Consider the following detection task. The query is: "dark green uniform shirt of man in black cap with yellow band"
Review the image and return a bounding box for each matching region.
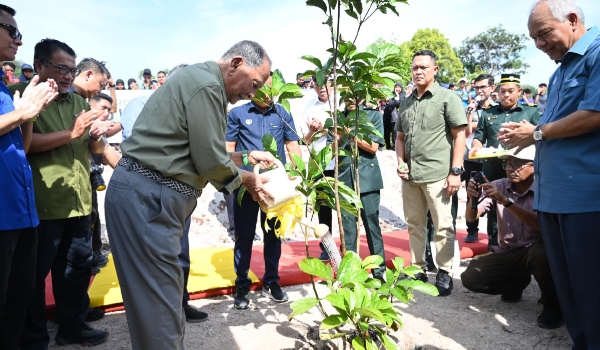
[475,103,540,181]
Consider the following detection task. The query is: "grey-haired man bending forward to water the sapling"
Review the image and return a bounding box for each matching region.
[105,41,274,350]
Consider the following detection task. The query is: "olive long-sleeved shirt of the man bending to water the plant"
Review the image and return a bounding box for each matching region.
[121,62,242,193]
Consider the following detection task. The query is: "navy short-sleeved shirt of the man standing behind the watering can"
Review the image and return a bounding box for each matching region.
[225,102,299,171]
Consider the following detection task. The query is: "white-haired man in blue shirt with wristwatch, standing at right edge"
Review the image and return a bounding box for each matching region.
[499,0,600,349]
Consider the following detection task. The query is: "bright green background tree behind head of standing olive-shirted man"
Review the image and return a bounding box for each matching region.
[400,28,464,83]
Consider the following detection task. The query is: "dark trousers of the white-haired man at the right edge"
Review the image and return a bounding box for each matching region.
[538,211,600,349]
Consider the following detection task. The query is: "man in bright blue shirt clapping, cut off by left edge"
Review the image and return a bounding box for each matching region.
[0,5,58,349]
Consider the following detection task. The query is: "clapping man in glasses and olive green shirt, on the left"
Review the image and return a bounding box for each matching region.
[15,39,108,349]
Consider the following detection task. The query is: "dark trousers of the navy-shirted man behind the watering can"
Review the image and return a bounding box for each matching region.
[233,190,281,288]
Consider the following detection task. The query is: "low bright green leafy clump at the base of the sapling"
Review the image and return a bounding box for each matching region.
[289,252,438,349]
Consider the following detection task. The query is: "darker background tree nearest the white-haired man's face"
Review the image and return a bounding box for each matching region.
[456,24,529,75]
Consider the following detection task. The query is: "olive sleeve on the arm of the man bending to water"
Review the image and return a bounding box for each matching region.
[185,86,242,194]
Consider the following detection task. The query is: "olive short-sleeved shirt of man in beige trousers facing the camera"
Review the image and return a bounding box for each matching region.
[395,83,467,183]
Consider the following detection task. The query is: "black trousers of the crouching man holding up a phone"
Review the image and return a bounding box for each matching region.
[460,241,558,308]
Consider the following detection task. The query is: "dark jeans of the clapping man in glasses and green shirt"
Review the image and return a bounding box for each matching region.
[21,215,92,350]
